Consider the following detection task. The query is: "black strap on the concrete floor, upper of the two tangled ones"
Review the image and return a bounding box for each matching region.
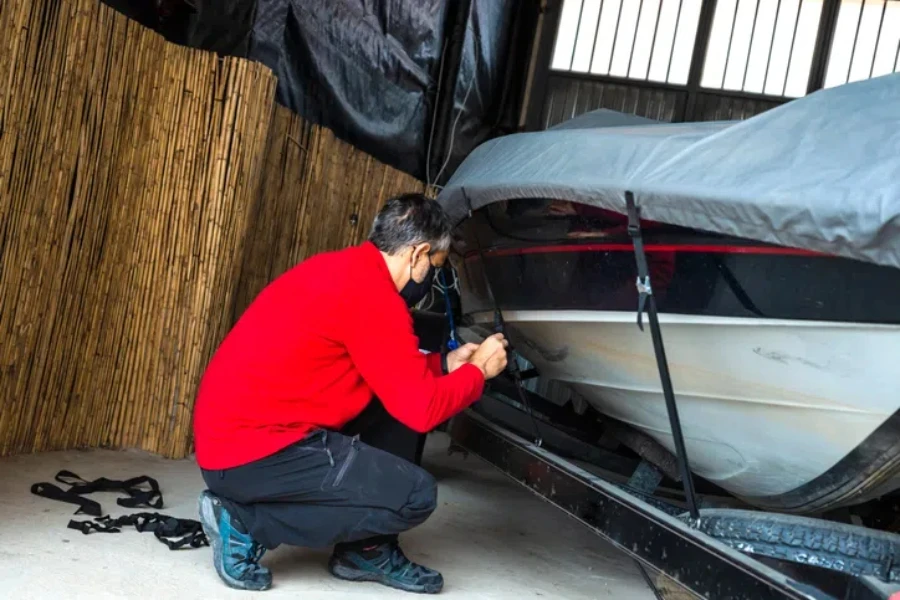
[31,471,163,517]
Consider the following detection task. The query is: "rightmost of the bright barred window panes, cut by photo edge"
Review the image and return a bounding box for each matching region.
[825,0,900,87]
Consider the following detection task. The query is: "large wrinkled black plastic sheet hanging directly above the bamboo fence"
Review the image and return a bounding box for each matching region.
[262,0,445,176]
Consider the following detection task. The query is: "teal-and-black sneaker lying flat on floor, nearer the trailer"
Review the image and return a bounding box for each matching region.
[328,542,444,594]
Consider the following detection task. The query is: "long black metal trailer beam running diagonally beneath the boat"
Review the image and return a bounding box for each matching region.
[448,409,900,600]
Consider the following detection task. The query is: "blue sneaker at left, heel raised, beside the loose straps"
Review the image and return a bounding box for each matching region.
[199,490,272,591]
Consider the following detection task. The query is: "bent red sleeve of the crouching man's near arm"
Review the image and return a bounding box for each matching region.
[344,294,484,433]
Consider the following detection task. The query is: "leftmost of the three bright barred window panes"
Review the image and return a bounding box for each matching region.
[551,0,702,85]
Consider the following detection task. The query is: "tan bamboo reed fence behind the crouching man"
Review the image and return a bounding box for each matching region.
[0,0,422,458]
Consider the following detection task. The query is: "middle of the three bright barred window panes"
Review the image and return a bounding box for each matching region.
[700,0,822,97]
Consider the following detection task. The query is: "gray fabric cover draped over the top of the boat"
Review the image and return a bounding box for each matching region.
[438,74,900,268]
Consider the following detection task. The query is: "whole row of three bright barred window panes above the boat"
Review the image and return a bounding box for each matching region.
[551,0,900,98]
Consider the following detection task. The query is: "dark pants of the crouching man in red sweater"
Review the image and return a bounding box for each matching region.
[203,400,437,549]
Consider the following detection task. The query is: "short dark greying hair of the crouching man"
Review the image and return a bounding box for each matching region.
[369,193,453,254]
